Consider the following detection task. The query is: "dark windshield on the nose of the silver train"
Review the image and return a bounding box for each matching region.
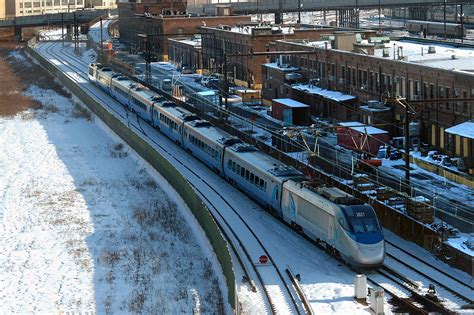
[344,205,380,233]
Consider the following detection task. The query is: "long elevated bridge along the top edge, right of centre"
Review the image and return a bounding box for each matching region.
[188,0,474,14]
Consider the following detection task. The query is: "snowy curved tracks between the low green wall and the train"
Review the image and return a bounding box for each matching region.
[39,43,312,314]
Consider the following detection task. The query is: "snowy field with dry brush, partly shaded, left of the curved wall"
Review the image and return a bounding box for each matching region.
[0,54,228,314]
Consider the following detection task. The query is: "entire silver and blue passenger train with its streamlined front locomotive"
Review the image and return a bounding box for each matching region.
[88,64,385,268]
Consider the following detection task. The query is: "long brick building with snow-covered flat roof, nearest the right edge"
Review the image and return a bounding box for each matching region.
[262,40,474,170]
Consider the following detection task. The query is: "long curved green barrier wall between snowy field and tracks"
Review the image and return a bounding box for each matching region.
[26,39,239,313]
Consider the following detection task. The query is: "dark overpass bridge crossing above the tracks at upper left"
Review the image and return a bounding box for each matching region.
[0,9,116,29]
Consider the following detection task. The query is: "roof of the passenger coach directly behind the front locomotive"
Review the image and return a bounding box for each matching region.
[229,143,303,178]
